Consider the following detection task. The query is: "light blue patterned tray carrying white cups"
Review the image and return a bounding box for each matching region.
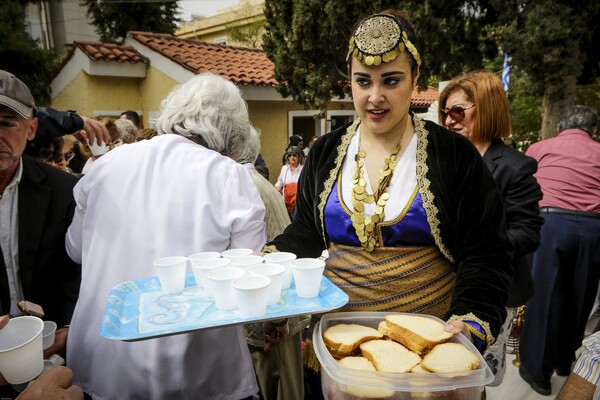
[100,273,348,341]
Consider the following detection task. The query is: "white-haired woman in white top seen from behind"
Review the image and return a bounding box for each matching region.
[67,74,288,400]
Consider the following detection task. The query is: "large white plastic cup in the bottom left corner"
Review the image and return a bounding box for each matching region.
[0,316,44,385]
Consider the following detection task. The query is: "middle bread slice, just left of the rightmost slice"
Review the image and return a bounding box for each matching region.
[360,340,421,372]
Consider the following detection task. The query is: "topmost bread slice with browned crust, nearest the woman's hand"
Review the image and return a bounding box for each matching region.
[385,314,453,354]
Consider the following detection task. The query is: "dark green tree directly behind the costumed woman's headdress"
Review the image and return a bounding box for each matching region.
[263,0,496,109]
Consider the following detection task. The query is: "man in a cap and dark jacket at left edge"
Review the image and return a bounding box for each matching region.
[0,70,81,397]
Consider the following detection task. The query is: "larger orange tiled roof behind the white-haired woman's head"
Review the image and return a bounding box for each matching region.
[130,32,277,86]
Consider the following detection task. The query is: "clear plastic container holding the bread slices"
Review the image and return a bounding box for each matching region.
[313,312,494,400]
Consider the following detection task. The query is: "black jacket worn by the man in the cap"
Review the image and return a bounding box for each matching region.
[0,155,81,327]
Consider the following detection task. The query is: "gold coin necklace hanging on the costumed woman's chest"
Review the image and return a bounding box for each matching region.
[350,130,408,252]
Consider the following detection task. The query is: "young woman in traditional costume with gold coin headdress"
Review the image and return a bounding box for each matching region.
[264,10,512,362]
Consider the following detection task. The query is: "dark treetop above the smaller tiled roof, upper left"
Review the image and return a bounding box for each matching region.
[83,0,181,43]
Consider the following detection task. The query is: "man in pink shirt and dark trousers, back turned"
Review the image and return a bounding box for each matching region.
[519,106,600,396]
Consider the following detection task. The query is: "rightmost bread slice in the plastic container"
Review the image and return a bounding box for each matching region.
[421,342,479,372]
